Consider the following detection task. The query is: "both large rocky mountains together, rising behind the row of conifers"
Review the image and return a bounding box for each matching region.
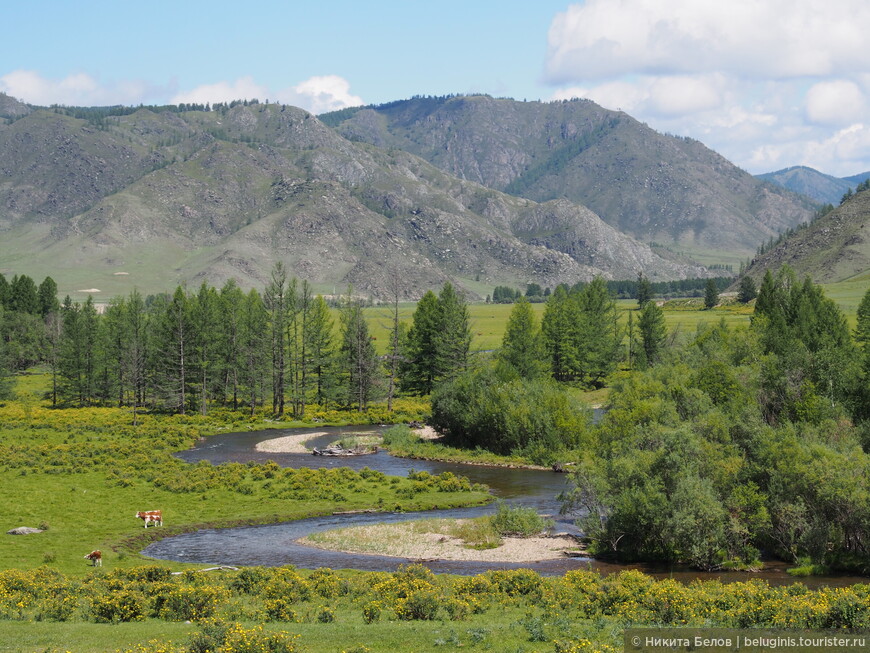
[0,94,809,298]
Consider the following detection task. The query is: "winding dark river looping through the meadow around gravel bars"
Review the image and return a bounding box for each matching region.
[143,426,867,587]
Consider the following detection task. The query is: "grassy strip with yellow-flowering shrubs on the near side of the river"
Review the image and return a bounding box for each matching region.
[0,565,870,653]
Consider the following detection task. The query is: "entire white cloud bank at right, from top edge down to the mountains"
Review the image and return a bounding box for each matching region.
[545,0,870,175]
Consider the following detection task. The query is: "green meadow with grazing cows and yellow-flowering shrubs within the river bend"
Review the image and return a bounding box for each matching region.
[0,376,491,574]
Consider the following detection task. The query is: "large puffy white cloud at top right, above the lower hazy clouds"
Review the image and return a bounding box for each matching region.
[547,0,870,84]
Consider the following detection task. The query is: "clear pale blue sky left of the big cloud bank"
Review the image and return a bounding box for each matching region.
[0,0,567,103]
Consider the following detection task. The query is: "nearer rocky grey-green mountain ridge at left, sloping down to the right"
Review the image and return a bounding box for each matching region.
[0,96,705,297]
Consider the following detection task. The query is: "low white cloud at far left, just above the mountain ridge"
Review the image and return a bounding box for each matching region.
[0,70,154,106]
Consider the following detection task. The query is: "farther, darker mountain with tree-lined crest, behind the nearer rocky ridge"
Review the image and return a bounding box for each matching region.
[321,96,813,253]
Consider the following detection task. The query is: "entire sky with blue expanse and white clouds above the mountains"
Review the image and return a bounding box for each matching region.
[0,0,870,176]
